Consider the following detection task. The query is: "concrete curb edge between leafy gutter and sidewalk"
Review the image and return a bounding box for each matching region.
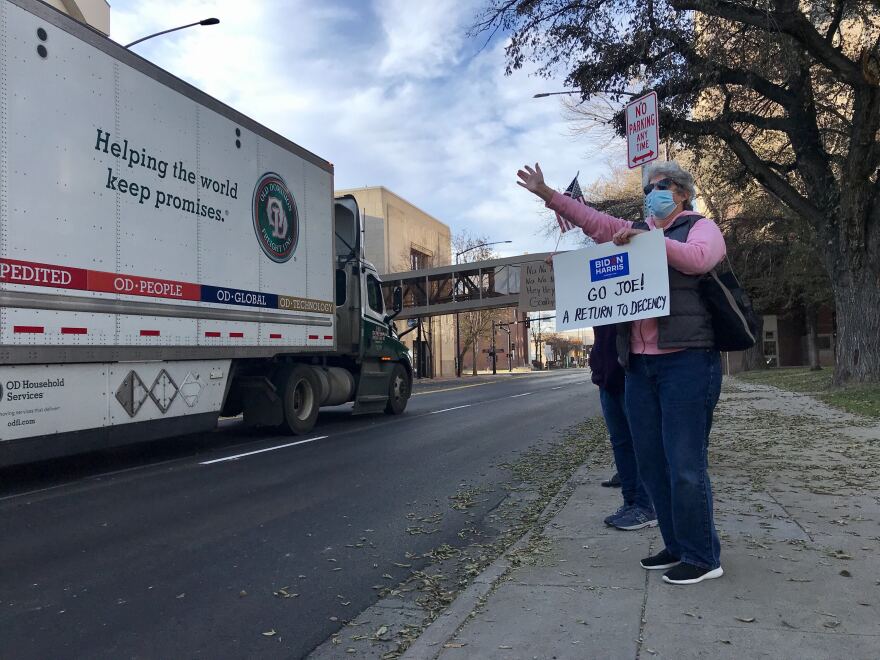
[400,466,585,660]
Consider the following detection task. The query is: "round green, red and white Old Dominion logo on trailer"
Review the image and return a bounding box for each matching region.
[252,172,299,263]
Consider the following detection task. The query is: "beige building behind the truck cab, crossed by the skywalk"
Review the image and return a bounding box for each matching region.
[336,186,455,378]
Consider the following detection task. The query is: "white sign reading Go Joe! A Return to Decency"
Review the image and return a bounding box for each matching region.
[553,229,669,330]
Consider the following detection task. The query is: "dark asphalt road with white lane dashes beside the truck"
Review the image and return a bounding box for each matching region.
[0,370,599,658]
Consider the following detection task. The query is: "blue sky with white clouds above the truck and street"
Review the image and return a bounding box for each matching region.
[110,0,626,256]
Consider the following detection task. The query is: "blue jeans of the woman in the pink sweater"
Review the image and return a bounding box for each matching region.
[626,349,721,569]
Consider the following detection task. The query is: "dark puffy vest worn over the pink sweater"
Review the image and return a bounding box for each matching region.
[617,213,715,367]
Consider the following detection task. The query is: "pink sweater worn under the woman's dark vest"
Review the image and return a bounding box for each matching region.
[547,193,727,355]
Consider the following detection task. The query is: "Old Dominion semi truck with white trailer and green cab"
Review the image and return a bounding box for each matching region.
[0,0,413,466]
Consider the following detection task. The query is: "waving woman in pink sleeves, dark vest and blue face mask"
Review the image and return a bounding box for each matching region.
[517,161,726,584]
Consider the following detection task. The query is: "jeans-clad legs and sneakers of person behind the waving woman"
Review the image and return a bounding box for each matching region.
[589,325,657,530]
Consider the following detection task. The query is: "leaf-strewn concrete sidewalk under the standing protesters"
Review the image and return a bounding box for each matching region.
[403,379,880,660]
